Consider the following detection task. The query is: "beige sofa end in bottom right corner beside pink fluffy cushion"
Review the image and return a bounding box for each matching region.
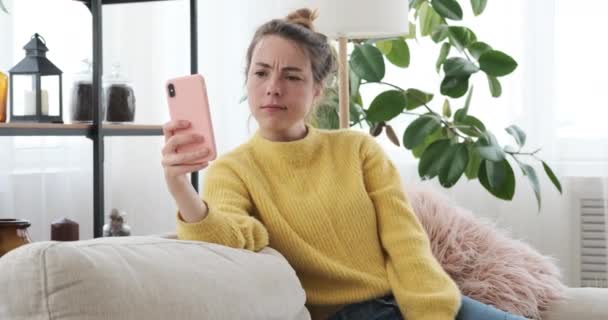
[542,288,608,320]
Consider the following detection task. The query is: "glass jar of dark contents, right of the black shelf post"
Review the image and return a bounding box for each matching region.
[104,64,135,122]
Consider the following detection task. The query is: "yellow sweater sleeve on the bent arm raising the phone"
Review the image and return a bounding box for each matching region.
[177,162,268,251]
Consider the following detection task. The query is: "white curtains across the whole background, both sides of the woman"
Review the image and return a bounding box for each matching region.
[0,0,608,285]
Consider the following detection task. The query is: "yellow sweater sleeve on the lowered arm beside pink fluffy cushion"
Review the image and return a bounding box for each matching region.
[361,137,460,320]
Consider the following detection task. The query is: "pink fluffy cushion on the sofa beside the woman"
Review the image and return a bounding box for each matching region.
[407,186,565,319]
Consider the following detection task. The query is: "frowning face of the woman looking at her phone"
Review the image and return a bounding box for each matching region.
[247,35,321,132]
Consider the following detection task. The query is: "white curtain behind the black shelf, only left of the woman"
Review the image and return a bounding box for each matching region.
[0,0,290,240]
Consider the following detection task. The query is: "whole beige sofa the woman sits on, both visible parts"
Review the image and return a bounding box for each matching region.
[0,237,608,320]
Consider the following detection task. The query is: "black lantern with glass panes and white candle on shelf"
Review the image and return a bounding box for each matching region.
[9,33,63,123]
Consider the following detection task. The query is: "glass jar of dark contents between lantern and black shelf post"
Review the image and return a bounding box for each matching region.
[70,59,105,122]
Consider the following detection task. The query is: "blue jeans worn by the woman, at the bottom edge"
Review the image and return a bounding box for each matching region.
[328,295,526,320]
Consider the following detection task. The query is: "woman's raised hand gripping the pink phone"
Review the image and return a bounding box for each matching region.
[162,120,209,184]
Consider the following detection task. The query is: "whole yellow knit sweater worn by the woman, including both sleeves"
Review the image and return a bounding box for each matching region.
[177,127,460,320]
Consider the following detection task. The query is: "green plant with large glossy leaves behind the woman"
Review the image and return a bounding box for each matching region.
[316,0,562,210]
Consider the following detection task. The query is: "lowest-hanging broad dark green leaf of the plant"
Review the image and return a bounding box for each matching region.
[478,159,515,200]
